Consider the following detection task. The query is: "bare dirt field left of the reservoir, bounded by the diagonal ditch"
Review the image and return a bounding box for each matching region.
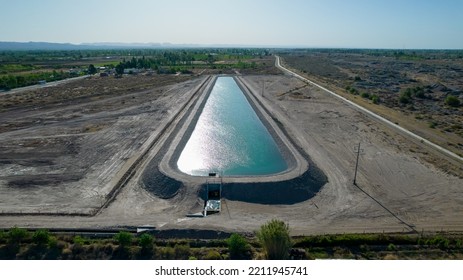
[0,74,201,214]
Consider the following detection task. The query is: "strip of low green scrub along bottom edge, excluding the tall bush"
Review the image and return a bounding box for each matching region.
[0,228,463,260]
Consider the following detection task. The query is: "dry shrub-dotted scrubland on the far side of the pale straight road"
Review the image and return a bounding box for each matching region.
[284,50,463,176]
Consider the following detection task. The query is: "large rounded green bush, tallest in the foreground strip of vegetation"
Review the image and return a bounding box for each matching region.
[257,219,291,260]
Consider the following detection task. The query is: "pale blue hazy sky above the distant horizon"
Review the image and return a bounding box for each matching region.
[0,0,463,49]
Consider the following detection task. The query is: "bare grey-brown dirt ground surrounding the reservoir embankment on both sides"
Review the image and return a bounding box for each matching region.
[0,70,463,235]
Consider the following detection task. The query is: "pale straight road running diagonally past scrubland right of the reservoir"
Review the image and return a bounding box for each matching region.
[275,56,463,162]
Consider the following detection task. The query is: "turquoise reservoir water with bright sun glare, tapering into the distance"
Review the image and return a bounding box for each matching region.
[177,77,288,176]
